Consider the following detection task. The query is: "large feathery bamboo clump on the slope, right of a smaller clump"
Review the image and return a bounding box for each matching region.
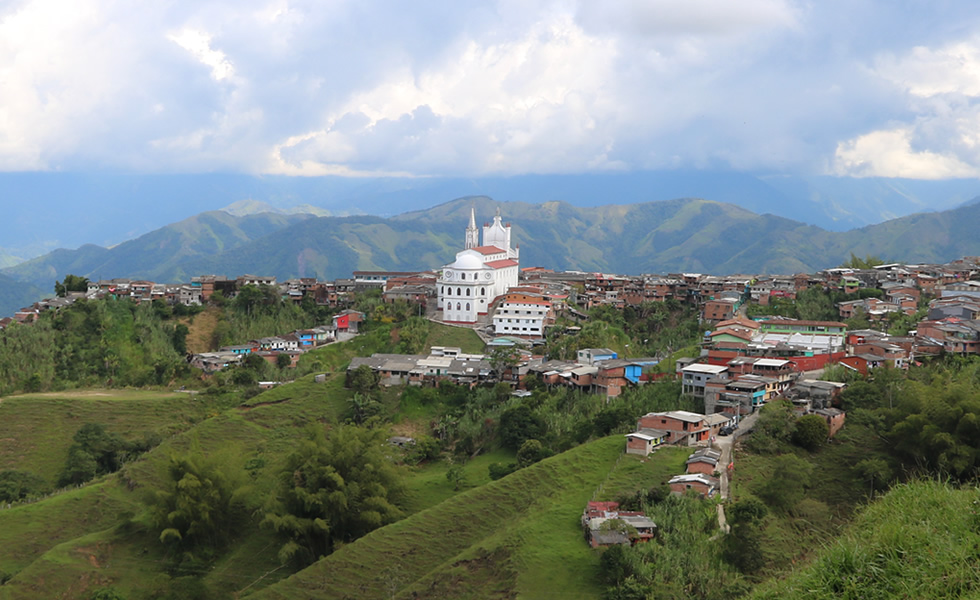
[263,425,402,565]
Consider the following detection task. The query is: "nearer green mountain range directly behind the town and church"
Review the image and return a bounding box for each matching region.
[0,196,980,314]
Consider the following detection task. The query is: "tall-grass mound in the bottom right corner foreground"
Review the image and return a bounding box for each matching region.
[751,481,980,600]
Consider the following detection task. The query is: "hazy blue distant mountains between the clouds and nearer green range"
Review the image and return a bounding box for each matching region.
[0,170,980,268]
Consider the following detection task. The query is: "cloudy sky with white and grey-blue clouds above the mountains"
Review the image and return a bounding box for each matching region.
[0,0,980,179]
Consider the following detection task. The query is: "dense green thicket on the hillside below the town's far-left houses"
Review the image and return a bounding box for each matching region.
[0,288,348,394]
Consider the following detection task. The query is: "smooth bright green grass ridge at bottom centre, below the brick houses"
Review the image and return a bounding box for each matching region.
[249,436,686,599]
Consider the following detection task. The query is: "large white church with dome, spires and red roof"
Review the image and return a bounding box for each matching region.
[436,208,520,323]
